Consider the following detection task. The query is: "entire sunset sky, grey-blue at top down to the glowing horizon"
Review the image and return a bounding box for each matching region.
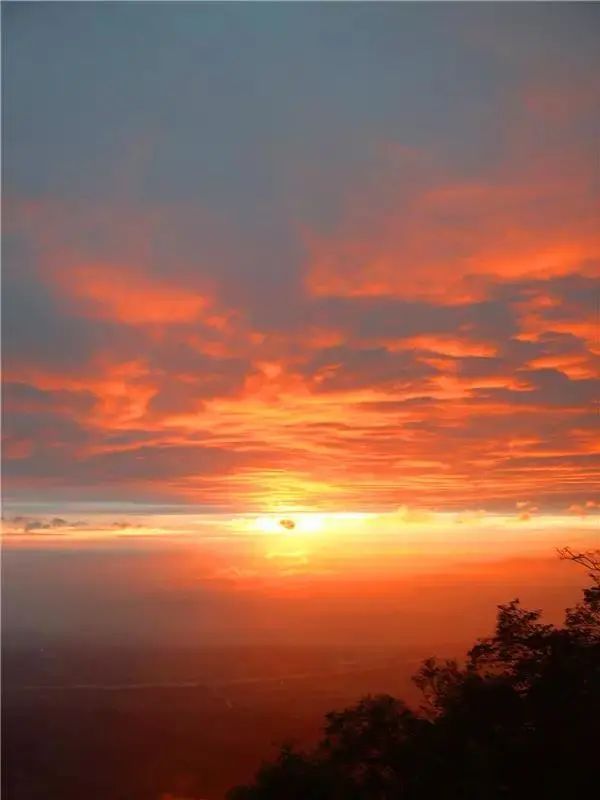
[2,3,600,600]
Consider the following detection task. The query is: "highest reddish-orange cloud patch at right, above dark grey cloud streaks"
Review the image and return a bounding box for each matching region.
[306,145,600,303]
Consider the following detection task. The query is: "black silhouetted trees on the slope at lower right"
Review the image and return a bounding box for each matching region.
[228,550,600,800]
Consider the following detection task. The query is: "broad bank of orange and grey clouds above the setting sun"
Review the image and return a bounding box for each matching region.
[5,122,600,516]
